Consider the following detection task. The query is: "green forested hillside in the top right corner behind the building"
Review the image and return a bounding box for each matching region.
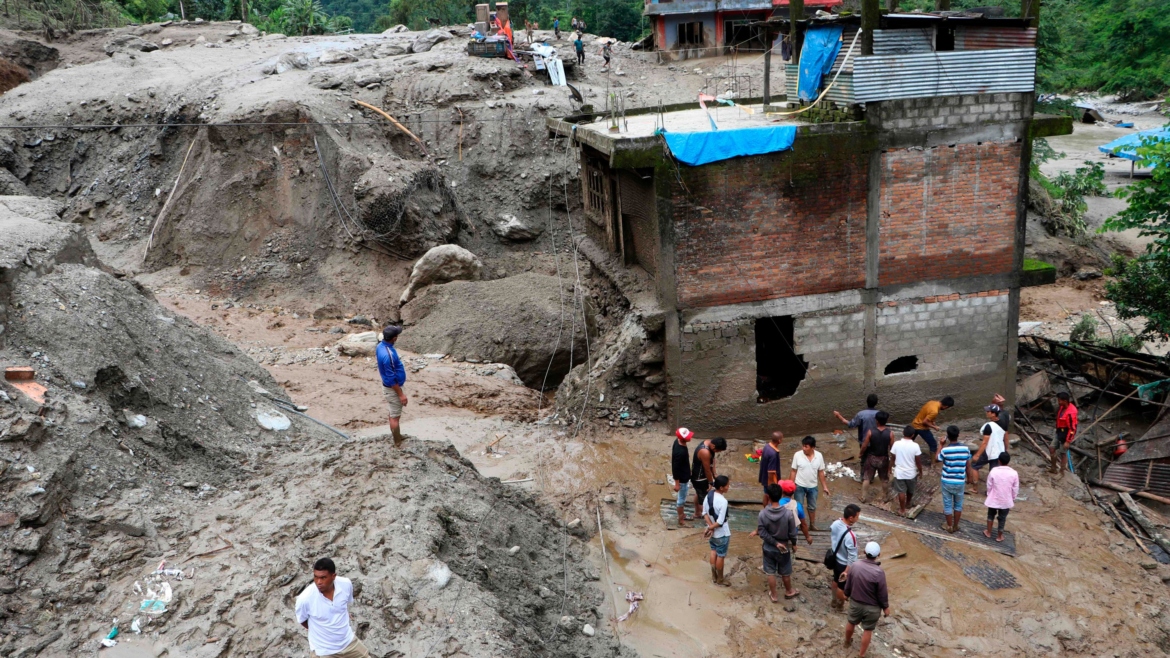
[1037,0,1170,100]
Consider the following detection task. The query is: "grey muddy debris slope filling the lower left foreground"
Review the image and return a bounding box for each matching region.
[0,197,621,658]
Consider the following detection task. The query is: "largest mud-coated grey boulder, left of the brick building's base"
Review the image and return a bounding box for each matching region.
[398,273,597,389]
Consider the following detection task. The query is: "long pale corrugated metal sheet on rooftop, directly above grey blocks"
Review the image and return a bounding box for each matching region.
[853,48,1035,103]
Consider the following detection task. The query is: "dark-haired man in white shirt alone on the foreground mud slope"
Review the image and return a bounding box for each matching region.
[296,557,370,658]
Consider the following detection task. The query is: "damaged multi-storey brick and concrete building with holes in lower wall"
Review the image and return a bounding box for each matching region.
[549,6,1072,436]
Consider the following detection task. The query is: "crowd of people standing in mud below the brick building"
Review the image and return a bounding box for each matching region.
[670,393,1043,656]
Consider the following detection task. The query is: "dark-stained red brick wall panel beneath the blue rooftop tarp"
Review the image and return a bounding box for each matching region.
[672,148,868,308]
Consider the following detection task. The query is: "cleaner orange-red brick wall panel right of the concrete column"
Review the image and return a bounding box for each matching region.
[878,142,1021,286]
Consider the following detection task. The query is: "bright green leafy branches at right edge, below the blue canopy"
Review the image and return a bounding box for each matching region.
[1102,134,1170,341]
